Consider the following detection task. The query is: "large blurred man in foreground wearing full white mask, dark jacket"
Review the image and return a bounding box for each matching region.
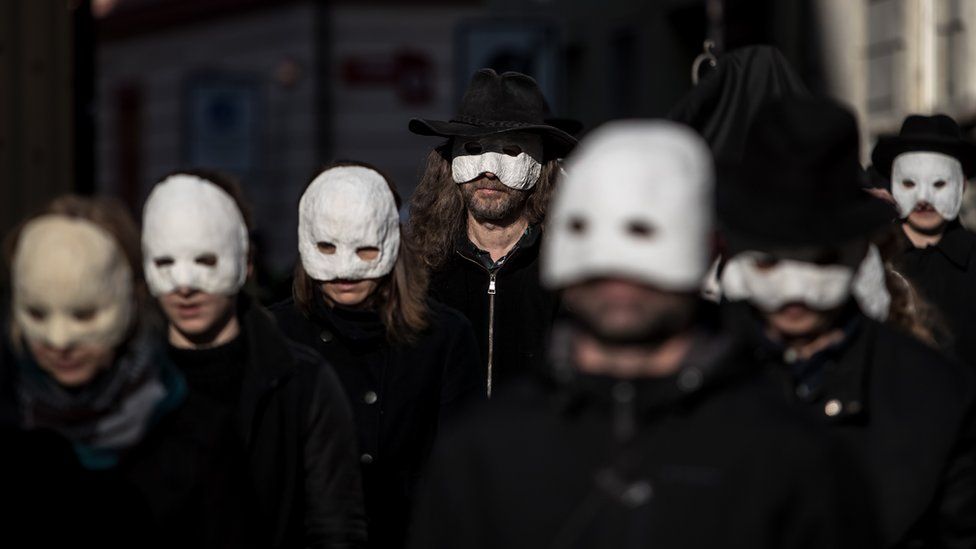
[413,121,872,549]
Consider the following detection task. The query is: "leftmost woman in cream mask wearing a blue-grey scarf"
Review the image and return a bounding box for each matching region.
[0,196,251,547]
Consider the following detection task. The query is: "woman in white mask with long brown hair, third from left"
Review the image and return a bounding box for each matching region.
[273,162,484,547]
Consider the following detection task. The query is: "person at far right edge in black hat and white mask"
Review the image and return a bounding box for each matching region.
[871,114,976,368]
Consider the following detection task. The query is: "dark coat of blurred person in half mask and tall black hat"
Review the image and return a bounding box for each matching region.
[727,304,976,547]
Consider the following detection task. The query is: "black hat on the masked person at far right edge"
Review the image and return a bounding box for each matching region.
[871,114,976,179]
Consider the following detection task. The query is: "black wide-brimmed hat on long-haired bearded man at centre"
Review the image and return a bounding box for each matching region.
[410,69,576,157]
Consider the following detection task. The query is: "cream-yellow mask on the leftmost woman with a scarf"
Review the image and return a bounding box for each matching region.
[12,215,134,349]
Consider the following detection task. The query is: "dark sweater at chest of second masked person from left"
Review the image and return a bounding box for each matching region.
[166,333,247,410]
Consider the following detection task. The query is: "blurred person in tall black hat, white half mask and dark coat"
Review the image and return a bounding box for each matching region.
[719,99,976,547]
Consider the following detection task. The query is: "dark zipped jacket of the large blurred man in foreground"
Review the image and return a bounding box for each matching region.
[411,316,873,549]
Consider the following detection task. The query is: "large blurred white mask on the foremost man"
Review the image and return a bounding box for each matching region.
[541,120,714,291]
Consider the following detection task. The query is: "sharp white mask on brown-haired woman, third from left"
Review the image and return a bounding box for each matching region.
[298,166,400,282]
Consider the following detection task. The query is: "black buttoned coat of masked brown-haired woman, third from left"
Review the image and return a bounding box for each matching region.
[272,293,483,548]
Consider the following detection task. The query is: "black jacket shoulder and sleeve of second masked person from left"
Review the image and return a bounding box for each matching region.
[229,302,366,548]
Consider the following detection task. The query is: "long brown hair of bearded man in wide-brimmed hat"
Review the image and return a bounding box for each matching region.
[408,141,559,270]
